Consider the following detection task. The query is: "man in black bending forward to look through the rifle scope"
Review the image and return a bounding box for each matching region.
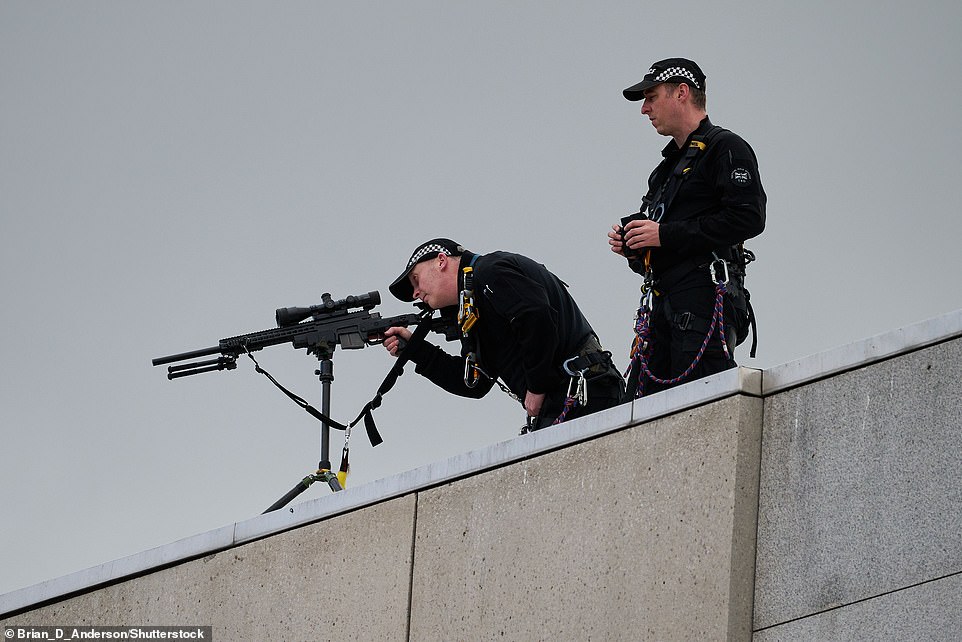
[384,238,623,430]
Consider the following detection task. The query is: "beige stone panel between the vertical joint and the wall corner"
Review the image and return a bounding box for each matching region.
[411,397,761,640]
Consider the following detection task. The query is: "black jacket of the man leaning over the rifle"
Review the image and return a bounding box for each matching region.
[406,252,594,399]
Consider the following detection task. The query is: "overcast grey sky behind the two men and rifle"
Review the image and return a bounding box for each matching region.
[0,0,962,592]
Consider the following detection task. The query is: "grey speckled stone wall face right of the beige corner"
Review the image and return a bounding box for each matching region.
[754,339,962,640]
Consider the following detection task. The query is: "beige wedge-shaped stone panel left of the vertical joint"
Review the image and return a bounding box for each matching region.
[2,496,415,641]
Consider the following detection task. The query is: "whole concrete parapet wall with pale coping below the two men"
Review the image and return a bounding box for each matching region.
[0,313,962,642]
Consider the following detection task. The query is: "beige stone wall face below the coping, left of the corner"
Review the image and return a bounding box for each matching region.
[5,395,762,640]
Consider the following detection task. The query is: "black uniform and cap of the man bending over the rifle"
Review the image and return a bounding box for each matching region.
[391,239,623,429]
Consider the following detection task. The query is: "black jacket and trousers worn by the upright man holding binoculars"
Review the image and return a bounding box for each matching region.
[628,117,766,396]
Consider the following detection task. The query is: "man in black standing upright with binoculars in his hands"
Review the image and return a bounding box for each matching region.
[608,58,766,398]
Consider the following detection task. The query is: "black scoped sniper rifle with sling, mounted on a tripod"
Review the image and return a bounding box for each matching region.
[151,291,458,512]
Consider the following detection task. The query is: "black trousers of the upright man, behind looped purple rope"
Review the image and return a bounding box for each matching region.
[626,283,737,399]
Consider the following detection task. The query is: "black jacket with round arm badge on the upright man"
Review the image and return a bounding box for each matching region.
[646,117,766,276]
